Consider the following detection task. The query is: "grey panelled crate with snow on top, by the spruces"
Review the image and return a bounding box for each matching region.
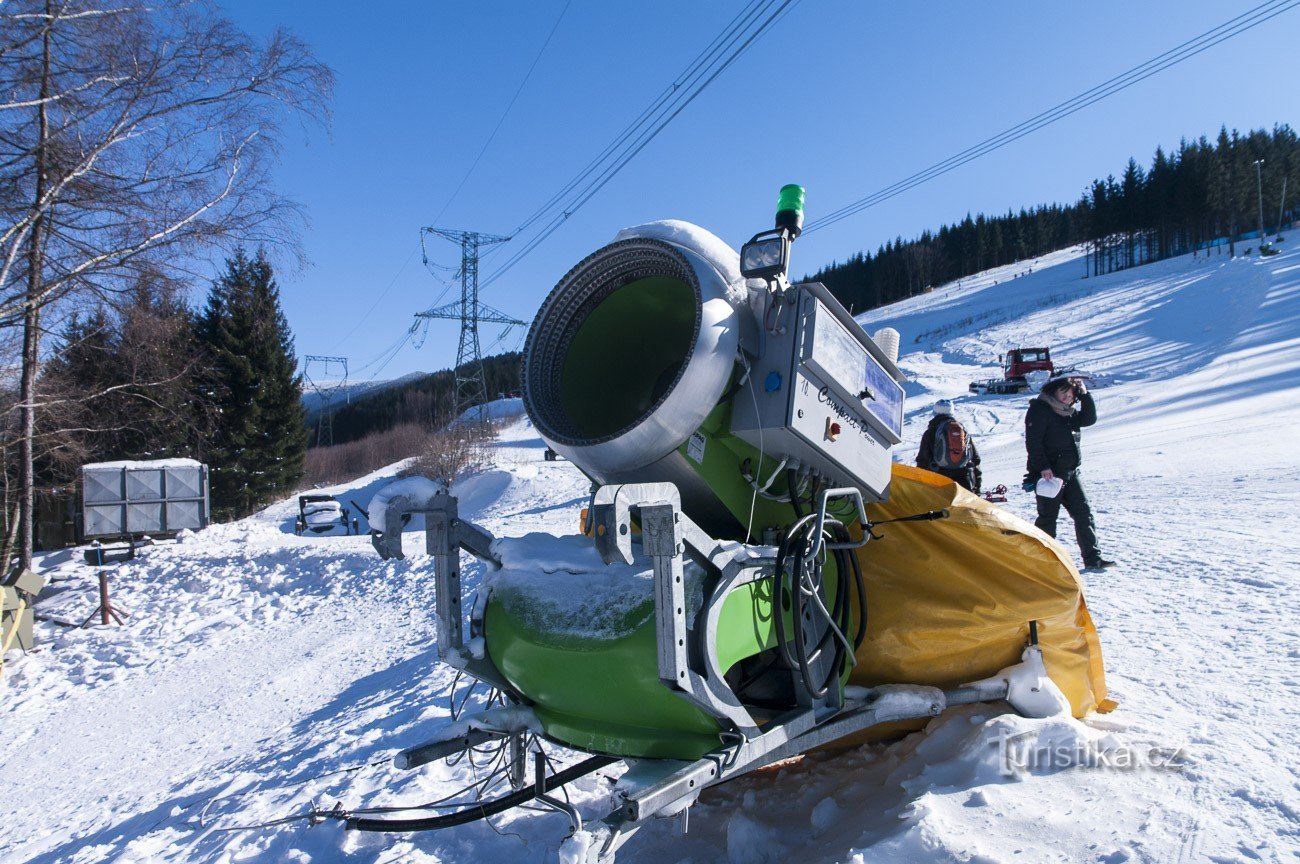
[81,459,208,539]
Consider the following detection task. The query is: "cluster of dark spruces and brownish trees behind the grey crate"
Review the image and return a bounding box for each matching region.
[38,249,307,518]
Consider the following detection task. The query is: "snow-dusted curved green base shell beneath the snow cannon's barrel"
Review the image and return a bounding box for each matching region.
[484,535,738,759]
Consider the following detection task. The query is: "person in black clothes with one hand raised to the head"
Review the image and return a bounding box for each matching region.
[1024,378,1114,569]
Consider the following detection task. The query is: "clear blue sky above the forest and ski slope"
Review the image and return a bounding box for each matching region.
[220,0,1300,379]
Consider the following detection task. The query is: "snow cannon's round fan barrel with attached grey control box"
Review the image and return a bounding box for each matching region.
[523,214,904,543]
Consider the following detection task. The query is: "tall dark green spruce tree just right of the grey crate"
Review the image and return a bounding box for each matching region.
[198,249,307,518]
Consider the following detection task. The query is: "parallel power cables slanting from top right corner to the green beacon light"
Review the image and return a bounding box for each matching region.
[803,0,1300,234]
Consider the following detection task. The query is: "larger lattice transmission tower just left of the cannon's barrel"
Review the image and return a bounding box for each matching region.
[416,227,525,417]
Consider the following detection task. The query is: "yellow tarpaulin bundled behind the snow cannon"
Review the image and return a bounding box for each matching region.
[850,464,1114,717]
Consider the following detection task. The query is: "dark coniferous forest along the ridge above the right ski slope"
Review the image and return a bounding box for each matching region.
[809,125,1300,312]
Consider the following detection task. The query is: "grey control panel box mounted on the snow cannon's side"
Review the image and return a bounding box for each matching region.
[732,282,904,502]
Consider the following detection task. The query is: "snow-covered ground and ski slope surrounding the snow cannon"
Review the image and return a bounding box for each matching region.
[0,244,1300,864]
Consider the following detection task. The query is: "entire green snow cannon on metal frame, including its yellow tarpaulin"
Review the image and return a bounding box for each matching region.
[356,186,1105,860]
